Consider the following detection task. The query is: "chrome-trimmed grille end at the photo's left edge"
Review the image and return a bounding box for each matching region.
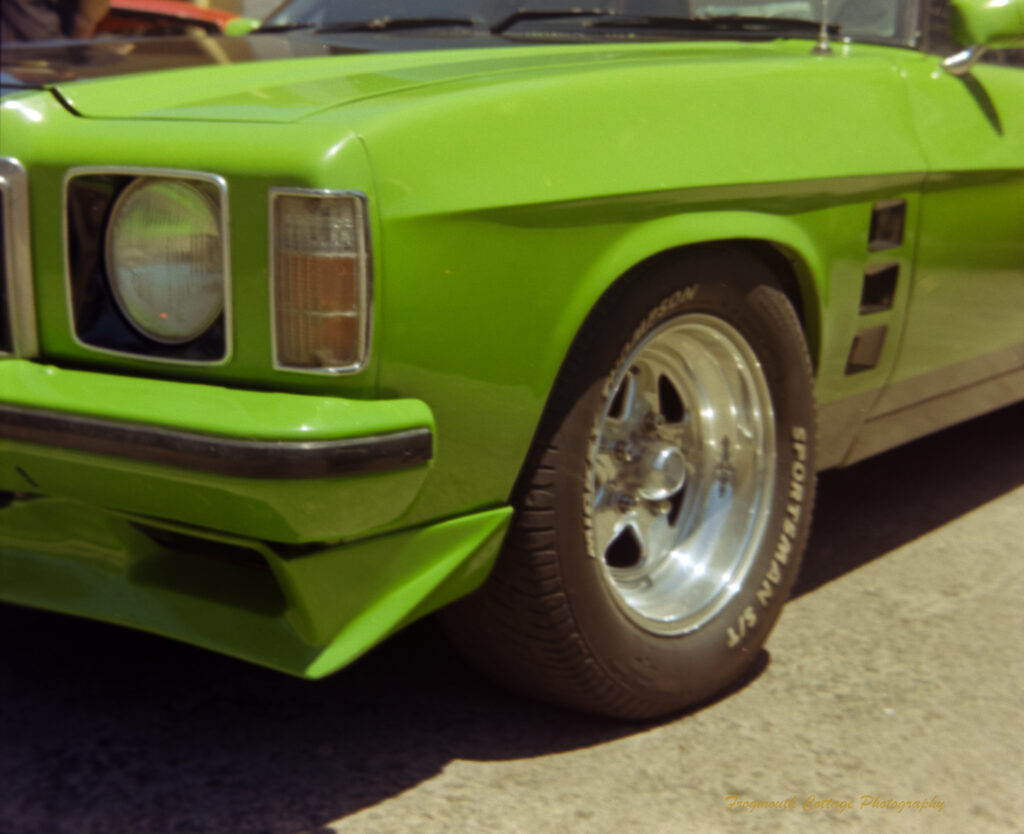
[0,157,39,357]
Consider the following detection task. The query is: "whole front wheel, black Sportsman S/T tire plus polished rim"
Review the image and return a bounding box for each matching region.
[447,249,815,718]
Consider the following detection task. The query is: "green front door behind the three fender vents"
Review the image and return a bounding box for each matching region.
[880,66,1024,393]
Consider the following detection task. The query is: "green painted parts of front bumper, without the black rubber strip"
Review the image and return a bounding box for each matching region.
[0,360,433,544]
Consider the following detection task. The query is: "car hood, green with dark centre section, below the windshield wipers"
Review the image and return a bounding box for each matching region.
[18,36,806,123]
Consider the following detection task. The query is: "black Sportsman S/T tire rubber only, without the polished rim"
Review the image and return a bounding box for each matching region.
[446,247,814,717]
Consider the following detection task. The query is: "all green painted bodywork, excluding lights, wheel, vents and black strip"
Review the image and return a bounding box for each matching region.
[0,24,1024,676]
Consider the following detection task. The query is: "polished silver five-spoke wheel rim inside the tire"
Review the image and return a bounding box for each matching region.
[586,314,776,635]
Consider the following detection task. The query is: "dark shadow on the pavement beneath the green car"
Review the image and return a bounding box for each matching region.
[0,407,1024,834]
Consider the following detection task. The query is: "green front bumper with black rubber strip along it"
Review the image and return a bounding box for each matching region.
[0,359,434,544]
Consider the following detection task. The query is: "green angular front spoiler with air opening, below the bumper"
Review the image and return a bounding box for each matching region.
[0,499,510,677]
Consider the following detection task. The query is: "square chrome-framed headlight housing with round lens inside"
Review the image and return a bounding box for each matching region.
[65,166,233,366]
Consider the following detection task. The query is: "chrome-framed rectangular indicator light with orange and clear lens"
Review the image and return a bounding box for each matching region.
[270,190,371,373]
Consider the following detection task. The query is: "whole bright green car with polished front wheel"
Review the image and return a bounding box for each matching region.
[0,0,1024,717]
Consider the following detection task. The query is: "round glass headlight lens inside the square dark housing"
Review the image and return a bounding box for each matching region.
[106,177,224,344]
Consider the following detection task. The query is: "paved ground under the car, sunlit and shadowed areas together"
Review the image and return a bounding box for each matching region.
[0,407,1024,834]
